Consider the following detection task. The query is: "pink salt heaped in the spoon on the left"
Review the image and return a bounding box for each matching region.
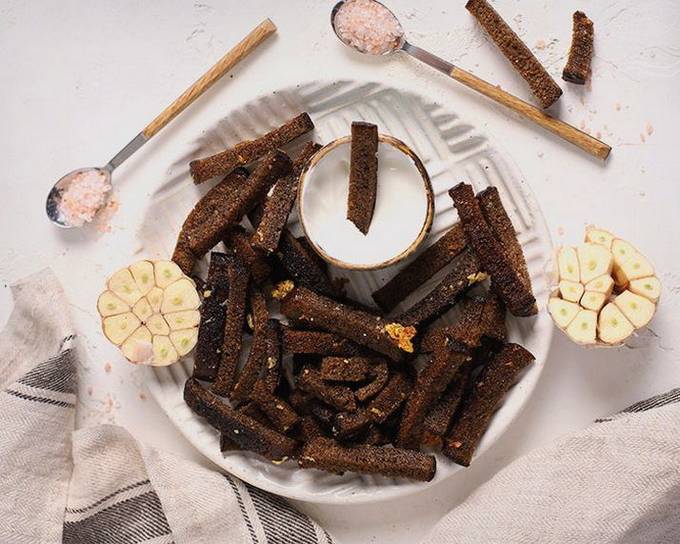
[59,169,111,227]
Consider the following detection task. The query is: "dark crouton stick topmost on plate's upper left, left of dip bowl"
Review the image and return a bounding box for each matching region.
[189,113,314,183]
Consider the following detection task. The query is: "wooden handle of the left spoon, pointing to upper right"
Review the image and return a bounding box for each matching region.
[142,19,276,140]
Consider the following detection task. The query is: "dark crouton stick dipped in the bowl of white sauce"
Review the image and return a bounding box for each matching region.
[347,121,378,234]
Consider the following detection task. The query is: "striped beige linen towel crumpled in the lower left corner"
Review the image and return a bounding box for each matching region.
[0,271,333,544]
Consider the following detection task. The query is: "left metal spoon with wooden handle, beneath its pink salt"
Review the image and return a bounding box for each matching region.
[45,19,276,228]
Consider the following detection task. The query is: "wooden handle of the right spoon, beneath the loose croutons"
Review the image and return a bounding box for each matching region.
[449,66,612,160]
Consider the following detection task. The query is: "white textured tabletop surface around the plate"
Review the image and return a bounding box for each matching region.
[0,0,680,544]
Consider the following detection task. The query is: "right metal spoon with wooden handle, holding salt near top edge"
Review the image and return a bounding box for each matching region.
[331,0,611,159]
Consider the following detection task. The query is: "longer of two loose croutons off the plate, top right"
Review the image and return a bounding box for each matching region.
[465,0,562,108]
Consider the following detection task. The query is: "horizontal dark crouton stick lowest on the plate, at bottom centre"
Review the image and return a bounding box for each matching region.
[299,437,437,482]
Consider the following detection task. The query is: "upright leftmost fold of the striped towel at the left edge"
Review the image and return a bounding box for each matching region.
[0,274,76,544]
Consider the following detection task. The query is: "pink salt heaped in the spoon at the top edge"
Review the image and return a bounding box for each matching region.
[334,0,404,55]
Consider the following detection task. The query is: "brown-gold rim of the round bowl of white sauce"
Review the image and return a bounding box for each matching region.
[296,133,434,270]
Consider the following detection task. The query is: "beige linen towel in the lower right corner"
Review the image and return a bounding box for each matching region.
[422,386,680,544]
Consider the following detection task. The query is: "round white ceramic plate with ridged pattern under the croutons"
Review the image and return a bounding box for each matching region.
[140,81,553,504]
